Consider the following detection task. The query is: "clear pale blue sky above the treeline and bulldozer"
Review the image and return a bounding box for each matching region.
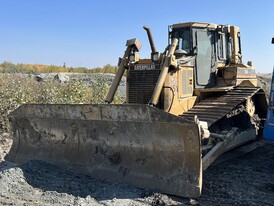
[0,0,274,73]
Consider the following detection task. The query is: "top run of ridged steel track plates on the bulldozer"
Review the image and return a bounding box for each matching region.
[181,87,261,127]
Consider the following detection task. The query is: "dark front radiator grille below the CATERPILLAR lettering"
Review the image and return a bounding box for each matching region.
[128,69,160,104]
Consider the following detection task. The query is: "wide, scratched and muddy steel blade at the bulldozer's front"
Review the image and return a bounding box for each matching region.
[6,105,202,197]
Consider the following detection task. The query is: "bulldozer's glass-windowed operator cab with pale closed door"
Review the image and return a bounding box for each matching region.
[169,22,241,89]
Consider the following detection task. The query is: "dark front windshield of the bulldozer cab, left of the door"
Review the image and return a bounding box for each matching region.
[171,28,191,54]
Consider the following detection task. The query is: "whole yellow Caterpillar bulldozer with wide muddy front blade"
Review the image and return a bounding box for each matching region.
[6,22,267,198]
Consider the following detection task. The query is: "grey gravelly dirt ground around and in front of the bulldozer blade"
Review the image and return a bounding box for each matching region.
[0,134,274,206]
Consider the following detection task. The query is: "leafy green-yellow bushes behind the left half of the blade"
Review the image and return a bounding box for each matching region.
[0,74,124,132]
